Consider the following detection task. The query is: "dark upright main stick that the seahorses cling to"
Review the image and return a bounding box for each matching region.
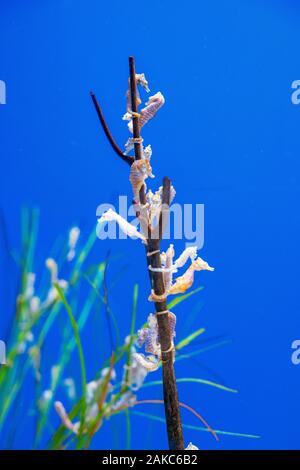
[129,57,185,450]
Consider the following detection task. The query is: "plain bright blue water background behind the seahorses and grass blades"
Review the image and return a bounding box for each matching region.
[0,0,300,449]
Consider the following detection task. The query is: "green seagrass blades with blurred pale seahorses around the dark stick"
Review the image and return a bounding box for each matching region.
[0,210,253,449]
